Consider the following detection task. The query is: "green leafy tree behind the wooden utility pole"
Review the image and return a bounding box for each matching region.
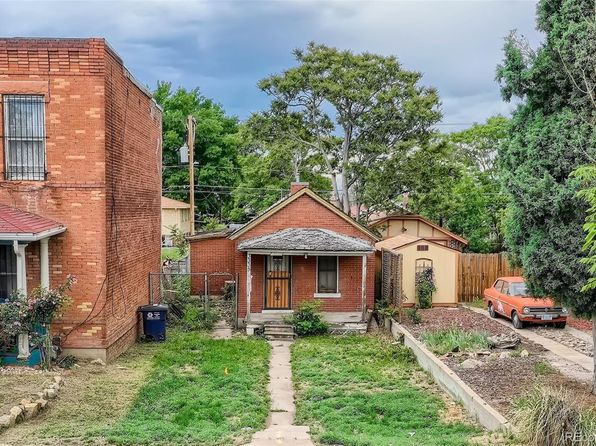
[154,82,240,223]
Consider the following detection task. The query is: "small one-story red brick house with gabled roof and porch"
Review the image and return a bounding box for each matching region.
[189,183,378,326]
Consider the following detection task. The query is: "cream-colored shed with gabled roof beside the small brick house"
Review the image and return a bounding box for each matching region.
[375,234,461,307]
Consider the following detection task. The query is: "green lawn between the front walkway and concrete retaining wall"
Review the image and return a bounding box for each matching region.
[292,336,478,446]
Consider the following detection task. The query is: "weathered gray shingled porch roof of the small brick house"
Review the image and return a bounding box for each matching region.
[238,228,374,254]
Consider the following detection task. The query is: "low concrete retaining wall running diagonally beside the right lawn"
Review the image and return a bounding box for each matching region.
[391,320,511,431]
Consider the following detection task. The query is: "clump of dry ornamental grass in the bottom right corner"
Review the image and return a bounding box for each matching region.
[513,387,596,446]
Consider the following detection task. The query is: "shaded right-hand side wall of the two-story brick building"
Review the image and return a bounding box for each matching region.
[104,49,161,356]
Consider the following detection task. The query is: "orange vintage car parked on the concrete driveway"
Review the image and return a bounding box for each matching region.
[484,277,567,328]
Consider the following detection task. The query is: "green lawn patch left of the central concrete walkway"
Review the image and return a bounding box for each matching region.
[106,333,269,445]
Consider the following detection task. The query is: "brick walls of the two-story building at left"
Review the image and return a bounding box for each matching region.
[0,39,161,358]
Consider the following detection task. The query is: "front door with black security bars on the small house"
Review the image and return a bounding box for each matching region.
[265,256,292,310]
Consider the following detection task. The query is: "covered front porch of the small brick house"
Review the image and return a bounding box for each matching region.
[238,228,374,326]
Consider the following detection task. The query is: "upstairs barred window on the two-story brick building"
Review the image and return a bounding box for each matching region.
[3,95,46,180]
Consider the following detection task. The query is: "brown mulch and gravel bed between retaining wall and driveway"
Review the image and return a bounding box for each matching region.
[403,308,596,417]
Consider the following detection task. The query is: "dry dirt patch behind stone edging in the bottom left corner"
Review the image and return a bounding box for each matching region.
[0,367,57,415]
